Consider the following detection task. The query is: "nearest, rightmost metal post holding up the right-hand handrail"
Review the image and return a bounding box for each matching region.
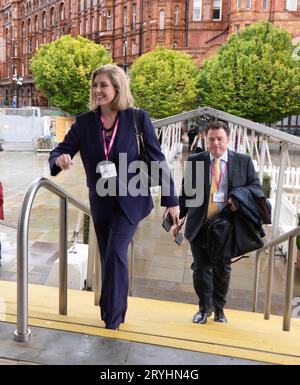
[282,236,296,332]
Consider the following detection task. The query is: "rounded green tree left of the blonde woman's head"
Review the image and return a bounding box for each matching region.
[30,35,111,115]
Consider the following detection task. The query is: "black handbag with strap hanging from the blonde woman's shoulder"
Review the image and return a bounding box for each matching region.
[133,108,159,187]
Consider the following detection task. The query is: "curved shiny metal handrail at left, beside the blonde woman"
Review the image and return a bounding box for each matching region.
[14,178,91,342]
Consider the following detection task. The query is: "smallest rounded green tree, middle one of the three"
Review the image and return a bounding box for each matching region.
[130,47,198,118]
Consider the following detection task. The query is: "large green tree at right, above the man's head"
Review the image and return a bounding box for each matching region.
[198,21,300,123]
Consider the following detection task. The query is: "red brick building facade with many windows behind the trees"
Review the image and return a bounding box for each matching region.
[0,0,300,106]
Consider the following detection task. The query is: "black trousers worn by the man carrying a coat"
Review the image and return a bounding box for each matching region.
[190,229,231,312]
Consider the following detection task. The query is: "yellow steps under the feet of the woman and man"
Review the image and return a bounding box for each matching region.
[0,281,300,365]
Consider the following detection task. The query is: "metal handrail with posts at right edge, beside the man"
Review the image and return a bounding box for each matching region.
[252,226,300,331]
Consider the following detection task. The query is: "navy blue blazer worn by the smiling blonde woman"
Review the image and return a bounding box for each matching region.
[49,108,179,224]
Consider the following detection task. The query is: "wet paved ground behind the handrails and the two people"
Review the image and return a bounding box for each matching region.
[0,147,300,317]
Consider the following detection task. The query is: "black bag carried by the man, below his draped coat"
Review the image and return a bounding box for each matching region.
[203,206,264,264]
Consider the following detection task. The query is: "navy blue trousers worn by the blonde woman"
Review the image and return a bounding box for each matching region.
[91,200,137,329]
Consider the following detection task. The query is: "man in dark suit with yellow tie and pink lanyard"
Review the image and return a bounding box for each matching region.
[174,121,261,324]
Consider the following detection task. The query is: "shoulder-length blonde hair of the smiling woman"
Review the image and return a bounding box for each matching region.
[90,64,134,111]
